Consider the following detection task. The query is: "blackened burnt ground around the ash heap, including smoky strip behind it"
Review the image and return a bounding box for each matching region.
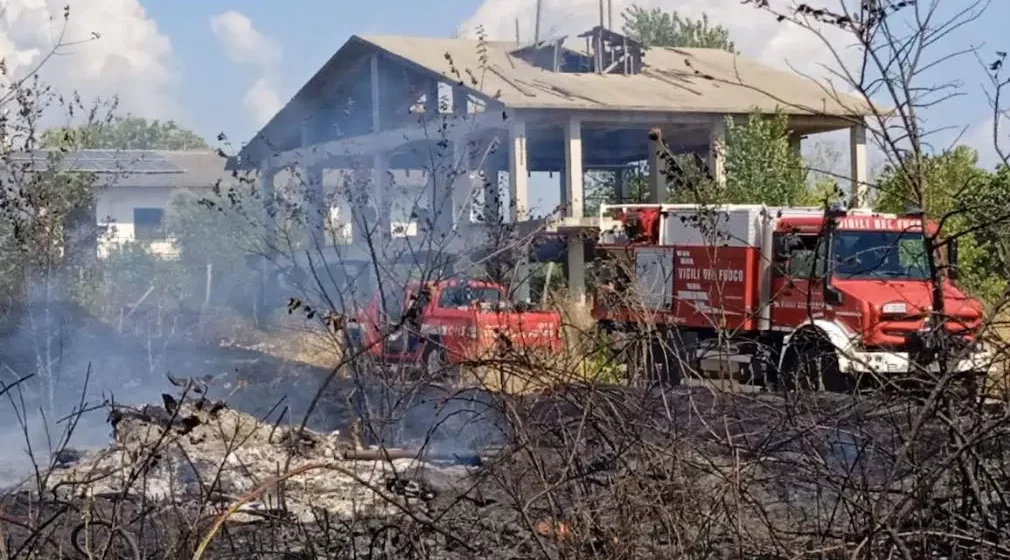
[0,313,1010,559]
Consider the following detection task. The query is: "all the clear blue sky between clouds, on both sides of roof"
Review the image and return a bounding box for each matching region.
[128,0,1010,162]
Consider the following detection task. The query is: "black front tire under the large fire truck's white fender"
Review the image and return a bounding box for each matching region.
[780,331,855,393]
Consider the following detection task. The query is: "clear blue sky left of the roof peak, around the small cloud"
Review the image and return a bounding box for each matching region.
[143,0,480,142]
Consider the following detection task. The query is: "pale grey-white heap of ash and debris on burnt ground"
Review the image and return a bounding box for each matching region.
[49,395,470,523]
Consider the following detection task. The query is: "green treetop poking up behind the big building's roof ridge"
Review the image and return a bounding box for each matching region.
[621,4,736,53]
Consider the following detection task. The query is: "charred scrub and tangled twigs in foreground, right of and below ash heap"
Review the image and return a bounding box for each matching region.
[4,378,1007,559]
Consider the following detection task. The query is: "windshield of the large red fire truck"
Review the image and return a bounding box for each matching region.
[831,226,929,280]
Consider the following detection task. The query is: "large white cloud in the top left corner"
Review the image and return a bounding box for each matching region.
[0,0,183,118]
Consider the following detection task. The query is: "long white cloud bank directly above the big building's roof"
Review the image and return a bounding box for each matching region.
[458,0,856,84]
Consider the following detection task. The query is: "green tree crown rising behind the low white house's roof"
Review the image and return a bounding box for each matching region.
[42,116,210,150]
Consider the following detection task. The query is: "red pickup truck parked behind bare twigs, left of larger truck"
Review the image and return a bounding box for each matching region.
[347,279,562,373]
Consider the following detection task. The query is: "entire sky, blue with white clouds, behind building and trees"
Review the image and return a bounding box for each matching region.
[7,0,1010,213]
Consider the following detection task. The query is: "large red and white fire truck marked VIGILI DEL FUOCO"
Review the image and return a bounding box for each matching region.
[592,204,989,391]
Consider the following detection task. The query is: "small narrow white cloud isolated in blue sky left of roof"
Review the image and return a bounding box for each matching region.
[210,10,284,127]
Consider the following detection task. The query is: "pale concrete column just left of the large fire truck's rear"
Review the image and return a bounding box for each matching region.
[563,114,586,305]
